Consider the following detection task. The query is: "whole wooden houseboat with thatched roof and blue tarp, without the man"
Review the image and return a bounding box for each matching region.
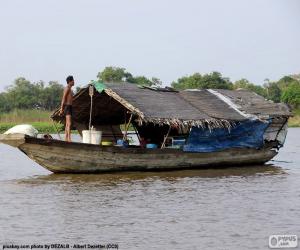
[0,82,291,173]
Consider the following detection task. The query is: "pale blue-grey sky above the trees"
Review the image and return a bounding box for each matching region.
[0,0,300,91]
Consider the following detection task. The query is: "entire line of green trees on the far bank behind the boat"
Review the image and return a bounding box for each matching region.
[0,66,300,112]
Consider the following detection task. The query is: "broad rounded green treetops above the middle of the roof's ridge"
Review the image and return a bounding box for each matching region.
[171,72,233,90]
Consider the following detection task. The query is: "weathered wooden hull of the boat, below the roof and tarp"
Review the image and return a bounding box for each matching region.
[0,136,277,173]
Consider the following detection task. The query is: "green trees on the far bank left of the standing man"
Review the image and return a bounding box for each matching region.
[0,77,63,112]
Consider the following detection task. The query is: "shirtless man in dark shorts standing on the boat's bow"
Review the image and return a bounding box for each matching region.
[59,76,74,142]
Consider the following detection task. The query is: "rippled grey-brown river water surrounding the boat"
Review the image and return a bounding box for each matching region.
[0,128,300,249]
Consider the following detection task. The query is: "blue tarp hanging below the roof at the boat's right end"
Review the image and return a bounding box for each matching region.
[183,120,269,152]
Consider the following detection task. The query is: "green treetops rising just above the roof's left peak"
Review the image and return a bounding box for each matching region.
[97,66,161,86]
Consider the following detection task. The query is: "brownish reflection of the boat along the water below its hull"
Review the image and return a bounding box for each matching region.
[17,164,286,185]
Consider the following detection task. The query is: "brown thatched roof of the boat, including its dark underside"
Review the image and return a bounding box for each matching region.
[52,82,290,128]
